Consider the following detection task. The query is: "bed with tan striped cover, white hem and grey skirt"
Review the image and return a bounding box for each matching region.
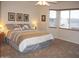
[7,24,54,53]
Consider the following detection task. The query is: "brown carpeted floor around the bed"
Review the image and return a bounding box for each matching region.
[0,39,79,58]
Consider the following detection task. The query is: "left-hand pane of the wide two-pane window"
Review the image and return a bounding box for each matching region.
[60,11,69,28]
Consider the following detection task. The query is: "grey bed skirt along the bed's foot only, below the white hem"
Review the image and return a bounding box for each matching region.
[23,40,53,53]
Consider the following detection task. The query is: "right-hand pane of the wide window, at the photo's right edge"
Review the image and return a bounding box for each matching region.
[70,10,79,29]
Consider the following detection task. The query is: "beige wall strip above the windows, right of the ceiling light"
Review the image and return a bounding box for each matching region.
[49,1,79,9]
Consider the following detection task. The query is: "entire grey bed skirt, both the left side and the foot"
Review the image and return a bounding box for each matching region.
[9,40,54,53]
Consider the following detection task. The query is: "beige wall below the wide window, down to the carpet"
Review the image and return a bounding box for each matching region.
[58,29,79,44]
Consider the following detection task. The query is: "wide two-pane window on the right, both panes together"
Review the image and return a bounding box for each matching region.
[60,10,79,29]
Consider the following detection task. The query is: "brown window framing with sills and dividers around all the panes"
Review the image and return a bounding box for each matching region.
[48,8,79,31]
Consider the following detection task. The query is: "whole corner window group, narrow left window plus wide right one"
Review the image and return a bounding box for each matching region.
[49,10,79,29]
